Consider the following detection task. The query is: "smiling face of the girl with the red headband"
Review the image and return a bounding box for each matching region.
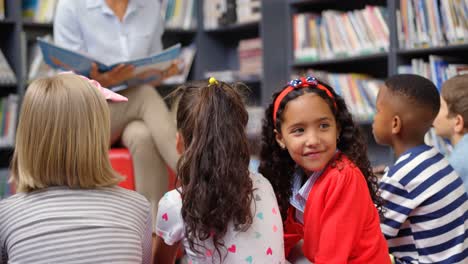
[275,93,339,174]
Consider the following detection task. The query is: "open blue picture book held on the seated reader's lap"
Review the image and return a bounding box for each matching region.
[37,38,180,91]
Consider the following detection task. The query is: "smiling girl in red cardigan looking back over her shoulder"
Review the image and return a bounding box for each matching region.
[259,77,390,264]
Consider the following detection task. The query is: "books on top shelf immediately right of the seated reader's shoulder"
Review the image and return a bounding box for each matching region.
[162,0,198,29]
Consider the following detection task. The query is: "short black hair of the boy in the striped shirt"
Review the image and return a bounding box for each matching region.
[385,74,440,116]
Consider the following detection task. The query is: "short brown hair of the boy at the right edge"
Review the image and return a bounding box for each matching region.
[441,74,468,128]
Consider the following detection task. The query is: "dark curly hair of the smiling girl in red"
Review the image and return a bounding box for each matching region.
[259,81,382,219]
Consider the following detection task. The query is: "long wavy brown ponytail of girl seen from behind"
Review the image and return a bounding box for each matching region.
[176,81,253,260]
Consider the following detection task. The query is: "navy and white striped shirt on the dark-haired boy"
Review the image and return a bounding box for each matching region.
[380,145,468,263]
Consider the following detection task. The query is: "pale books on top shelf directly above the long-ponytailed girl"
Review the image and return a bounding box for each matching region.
[203,0,261,29]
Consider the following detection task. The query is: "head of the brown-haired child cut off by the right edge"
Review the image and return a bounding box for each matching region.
[433,75,468,143]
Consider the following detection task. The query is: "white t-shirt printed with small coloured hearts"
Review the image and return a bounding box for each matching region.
[156,173,285,264]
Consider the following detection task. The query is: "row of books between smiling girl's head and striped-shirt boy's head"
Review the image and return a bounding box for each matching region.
[292,69,384,123]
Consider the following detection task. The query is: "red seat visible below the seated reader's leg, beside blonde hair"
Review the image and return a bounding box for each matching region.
[109,148,135,190]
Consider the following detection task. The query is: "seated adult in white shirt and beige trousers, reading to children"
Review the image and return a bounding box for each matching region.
[54,0,179,237]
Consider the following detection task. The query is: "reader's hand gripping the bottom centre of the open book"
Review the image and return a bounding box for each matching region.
[89,63,135,87]
